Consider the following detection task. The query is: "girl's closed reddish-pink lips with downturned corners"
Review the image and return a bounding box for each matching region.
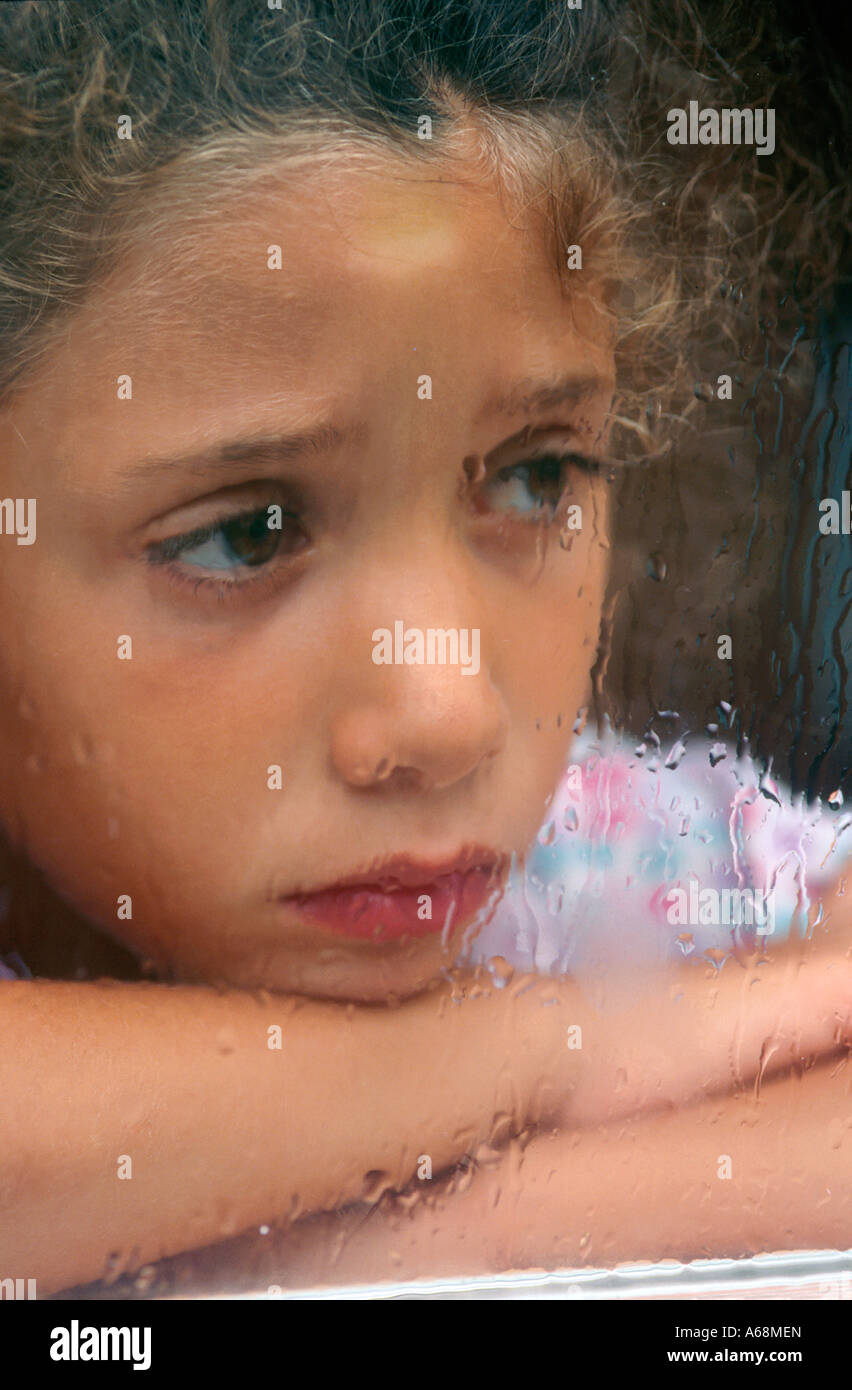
[278,848,507,942]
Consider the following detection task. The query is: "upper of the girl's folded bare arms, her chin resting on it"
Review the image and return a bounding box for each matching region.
[0,934,852,1293]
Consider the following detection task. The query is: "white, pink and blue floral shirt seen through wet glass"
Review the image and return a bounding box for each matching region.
[474,735,852,974]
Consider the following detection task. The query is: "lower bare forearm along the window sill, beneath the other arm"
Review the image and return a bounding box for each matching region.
[269,1063,852,1289]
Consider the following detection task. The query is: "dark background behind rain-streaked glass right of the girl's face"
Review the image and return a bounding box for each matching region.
[599,3,852,798]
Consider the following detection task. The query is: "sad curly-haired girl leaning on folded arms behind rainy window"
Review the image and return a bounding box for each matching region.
[0,0,852,1294]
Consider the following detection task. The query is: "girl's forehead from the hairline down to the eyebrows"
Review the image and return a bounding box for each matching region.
[6,158,613,478]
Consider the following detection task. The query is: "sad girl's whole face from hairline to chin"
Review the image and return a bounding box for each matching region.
[0,152,613,999]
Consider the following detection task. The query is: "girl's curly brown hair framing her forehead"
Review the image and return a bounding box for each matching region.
[0,0,849,467]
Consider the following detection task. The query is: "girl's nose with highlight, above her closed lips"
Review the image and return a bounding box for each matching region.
[331,603,509,791]
